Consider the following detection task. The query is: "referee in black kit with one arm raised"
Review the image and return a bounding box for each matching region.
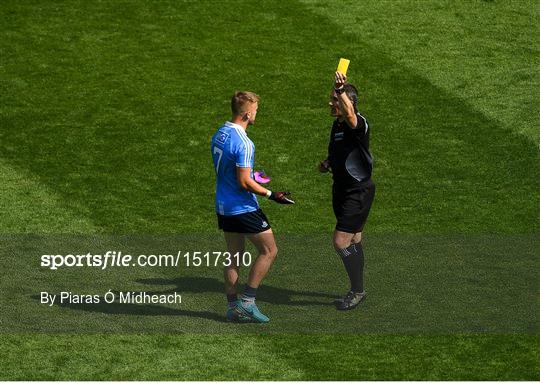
[319,72,375,310]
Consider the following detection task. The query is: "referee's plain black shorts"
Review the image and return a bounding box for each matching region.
[332,179,375,233]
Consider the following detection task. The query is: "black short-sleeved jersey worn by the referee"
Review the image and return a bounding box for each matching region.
[328,113,373,187]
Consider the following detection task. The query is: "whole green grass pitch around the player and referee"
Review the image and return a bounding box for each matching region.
[0,0,540,380]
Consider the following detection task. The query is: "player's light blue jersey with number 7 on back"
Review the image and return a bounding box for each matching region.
[211,121,259,215]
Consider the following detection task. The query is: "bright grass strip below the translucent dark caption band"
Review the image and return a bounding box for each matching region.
[0,334,540,381]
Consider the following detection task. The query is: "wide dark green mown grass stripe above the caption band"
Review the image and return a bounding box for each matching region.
[2,3,540,233]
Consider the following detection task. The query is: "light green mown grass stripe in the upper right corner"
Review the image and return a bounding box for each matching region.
[301,0,540,148]
